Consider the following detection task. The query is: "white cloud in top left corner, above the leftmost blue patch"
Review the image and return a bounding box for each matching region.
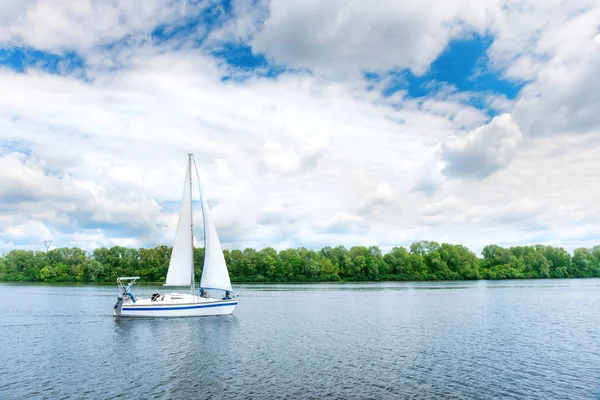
[0,0,205,53]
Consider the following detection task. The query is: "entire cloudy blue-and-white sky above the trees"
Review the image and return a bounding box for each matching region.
[0,0,600,253]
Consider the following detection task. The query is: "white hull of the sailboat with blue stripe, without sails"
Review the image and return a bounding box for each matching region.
[114,293,239,318]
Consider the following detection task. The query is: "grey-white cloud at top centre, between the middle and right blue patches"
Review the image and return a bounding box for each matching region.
[251,0,499,75]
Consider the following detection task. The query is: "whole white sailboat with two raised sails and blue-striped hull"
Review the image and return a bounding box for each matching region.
[114,154,239,317]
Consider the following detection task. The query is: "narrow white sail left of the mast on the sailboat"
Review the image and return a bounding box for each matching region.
[165,161,194,286]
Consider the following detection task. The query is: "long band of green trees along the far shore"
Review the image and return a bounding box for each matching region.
[0,241,600,282]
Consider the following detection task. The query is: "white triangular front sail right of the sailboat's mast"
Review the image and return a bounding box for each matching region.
[196,164,233,292]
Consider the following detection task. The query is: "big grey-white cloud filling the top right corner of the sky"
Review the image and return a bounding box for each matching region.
[489,0,600,136]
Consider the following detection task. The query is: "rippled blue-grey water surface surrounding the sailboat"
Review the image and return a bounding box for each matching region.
[0,279,600,399]
